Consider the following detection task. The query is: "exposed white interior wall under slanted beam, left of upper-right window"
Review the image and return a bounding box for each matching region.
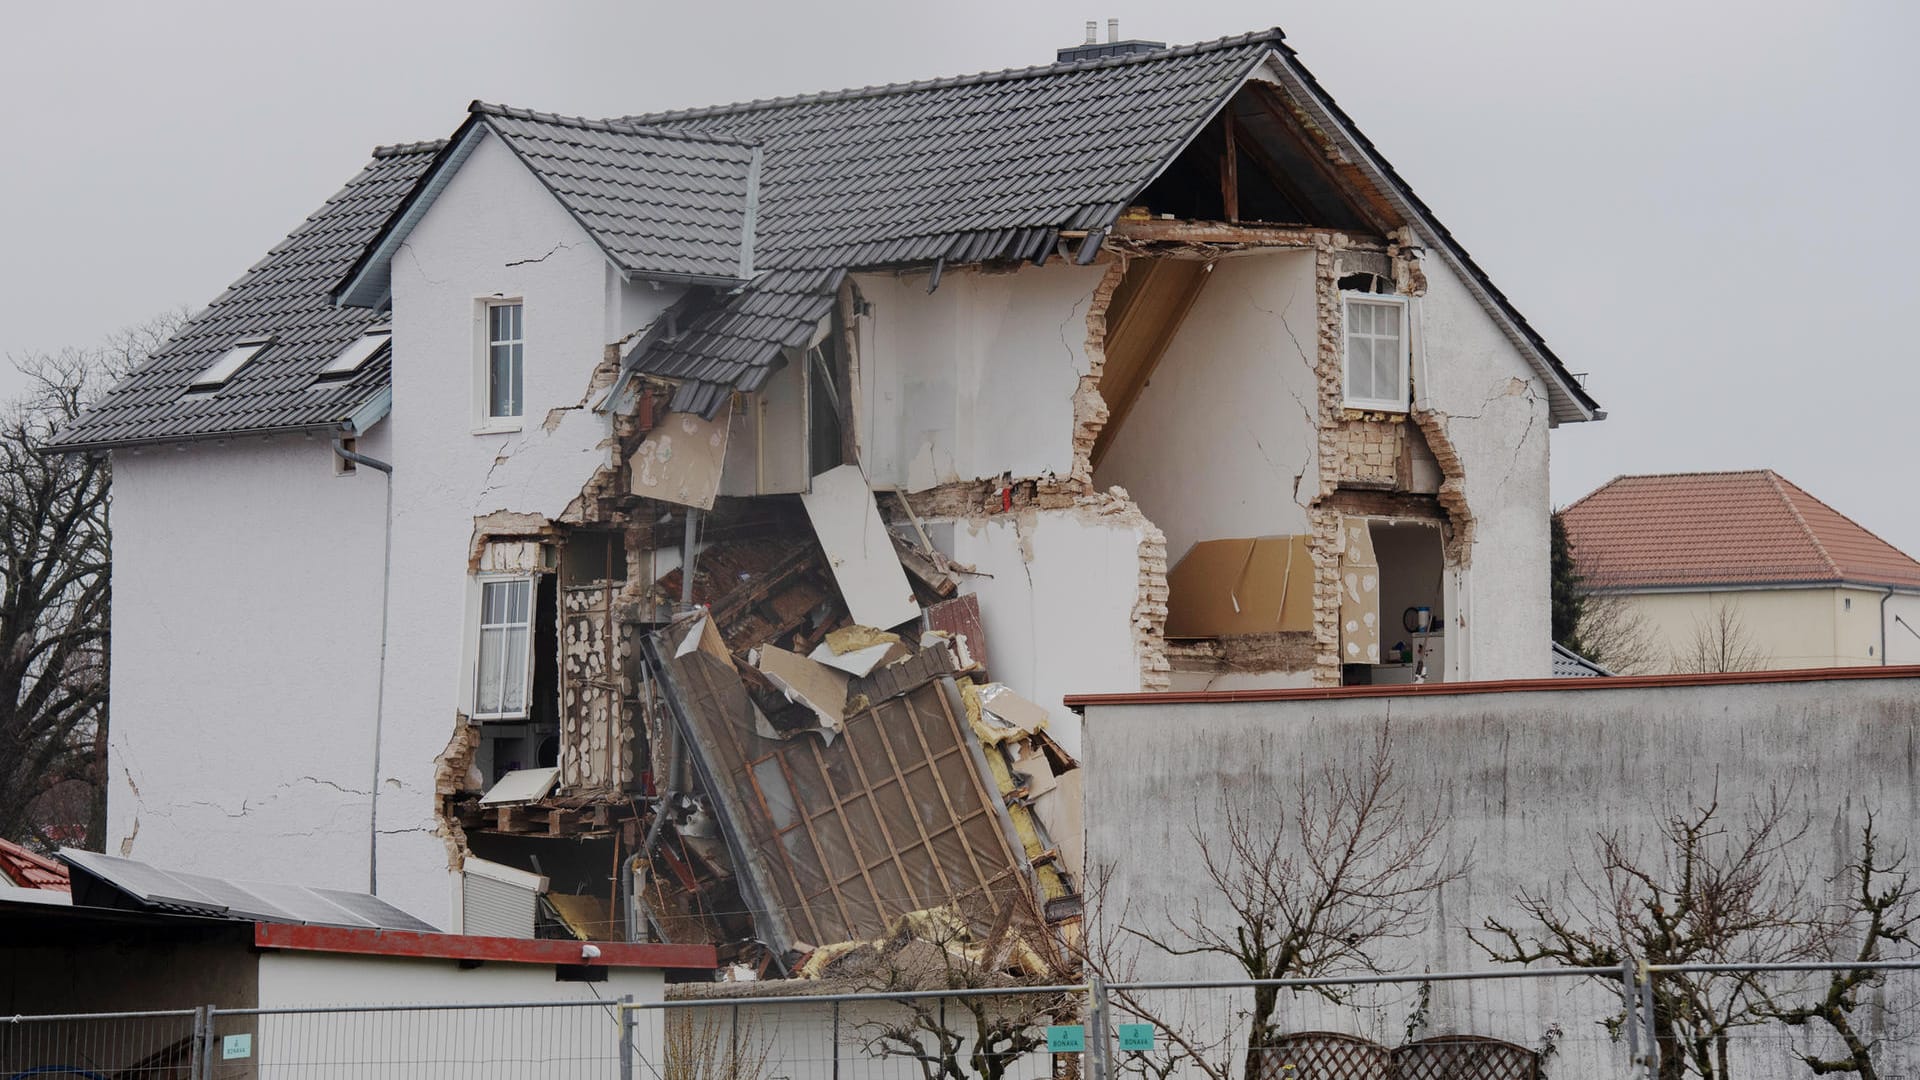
[1094,250,1319,563]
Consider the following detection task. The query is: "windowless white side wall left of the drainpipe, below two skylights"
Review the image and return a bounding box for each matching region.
[106,423,393,890]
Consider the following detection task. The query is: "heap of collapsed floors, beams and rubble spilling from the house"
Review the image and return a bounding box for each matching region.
[444,455,1081,976]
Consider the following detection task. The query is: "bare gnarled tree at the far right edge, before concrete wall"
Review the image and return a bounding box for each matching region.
[1766,815,1920,1080]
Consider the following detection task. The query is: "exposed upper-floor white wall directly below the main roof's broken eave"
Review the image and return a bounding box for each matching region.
[854,261,1106,492]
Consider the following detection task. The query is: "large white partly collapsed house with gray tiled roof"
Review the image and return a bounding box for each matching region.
[48,23,1603,944]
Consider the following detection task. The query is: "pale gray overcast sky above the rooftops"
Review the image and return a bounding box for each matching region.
[0,0,1920,555]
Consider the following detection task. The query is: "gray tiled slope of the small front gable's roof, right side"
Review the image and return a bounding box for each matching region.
[470,102,758,282]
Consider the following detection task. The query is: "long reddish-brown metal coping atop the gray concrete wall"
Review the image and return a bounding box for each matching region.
[1064,665,1920,713]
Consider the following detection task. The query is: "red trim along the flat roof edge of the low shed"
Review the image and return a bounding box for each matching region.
[253,922,720,970]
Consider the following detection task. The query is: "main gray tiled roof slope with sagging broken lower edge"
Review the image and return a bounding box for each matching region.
[624,31,1281,411]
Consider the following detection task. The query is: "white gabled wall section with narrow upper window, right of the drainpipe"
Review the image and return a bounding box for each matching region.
[369,125,678,924]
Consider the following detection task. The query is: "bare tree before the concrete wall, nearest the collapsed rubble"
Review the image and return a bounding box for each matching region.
[1129,726,1467,1080]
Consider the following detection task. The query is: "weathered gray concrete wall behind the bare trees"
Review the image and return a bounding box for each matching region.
[1083,675,1920,1067]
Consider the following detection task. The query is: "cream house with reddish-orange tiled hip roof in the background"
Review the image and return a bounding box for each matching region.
[1563,469,1920,671]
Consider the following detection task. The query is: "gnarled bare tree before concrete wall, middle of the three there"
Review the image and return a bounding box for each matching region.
[1471,792,1828,1080]
